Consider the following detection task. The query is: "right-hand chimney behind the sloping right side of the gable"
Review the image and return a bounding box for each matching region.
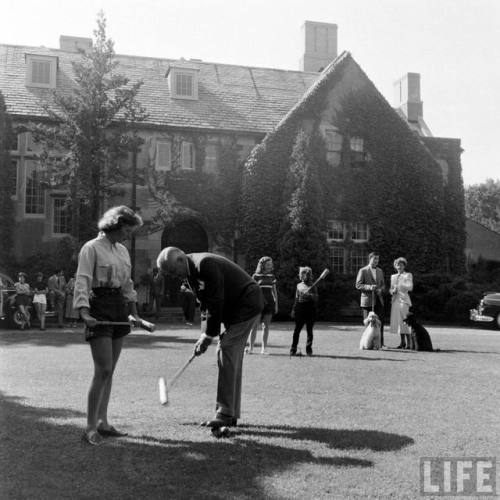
[394,73,432,137]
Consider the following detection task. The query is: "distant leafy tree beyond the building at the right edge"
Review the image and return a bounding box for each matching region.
[465,179,500,233]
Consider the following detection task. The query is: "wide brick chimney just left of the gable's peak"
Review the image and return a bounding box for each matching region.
[300,21,337,72]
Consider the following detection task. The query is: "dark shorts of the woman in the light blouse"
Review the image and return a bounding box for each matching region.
[85,288,130,342]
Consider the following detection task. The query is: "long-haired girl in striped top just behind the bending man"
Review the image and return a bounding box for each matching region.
[247,257,278,354]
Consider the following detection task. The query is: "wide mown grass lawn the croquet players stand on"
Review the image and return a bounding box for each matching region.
[0,323,500,500]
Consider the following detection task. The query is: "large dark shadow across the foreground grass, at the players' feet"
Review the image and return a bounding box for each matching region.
[0,393,413,500]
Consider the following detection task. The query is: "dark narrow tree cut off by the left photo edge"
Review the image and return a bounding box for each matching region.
[0,92,16,265]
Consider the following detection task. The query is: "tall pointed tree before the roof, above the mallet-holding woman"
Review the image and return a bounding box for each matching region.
[30,11,147,241]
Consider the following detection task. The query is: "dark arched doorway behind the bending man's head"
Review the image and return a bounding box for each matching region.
[161,220,208,307]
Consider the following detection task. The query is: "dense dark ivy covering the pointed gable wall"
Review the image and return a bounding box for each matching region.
[242,53,464,312]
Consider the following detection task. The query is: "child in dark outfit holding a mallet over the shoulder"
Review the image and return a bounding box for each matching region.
[290,267,318,356]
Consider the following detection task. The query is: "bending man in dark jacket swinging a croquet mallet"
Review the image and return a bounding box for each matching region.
[157,247,264,428]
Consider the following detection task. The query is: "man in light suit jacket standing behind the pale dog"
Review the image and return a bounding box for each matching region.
[356,252,385,346]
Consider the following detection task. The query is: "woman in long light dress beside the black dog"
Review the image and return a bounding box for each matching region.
[389,257,413,349]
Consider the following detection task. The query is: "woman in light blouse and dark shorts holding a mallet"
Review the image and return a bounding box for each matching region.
[73,206,142,446]
